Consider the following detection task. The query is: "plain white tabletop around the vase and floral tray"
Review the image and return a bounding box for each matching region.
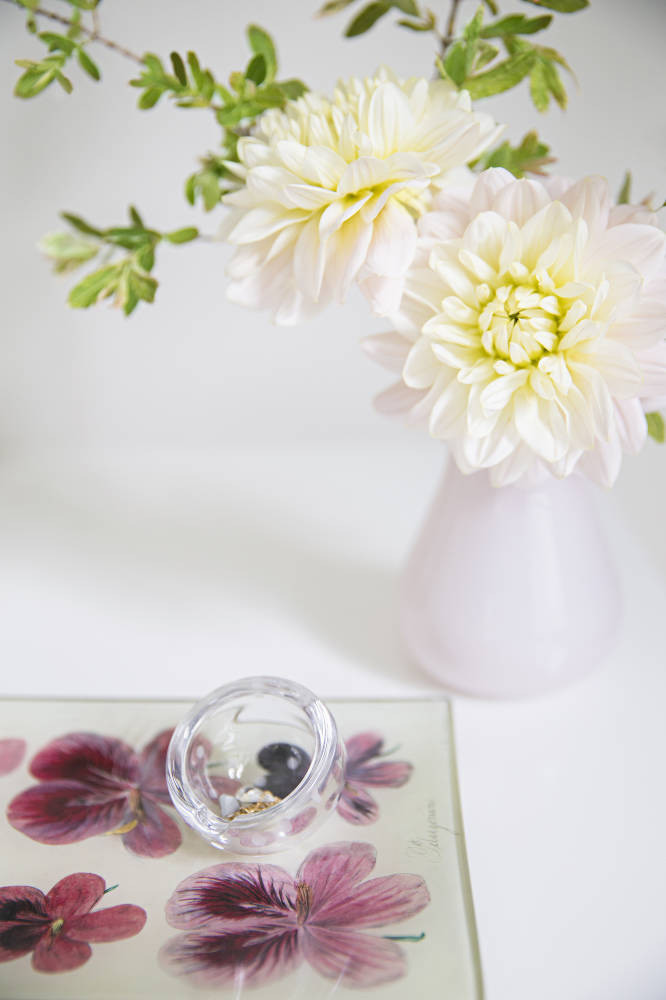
[0,450,666,1000]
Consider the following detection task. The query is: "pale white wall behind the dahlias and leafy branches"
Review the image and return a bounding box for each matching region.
[0,0,666,446]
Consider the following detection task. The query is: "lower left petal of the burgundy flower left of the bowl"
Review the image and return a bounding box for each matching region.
[7,781,128,844]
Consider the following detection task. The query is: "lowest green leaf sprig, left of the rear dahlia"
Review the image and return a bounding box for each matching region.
[39,207,199,316]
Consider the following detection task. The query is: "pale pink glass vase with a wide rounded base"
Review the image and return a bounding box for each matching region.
[400,461,621,698]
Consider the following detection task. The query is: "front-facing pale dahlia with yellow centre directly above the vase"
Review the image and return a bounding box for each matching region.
[366,169,666,486]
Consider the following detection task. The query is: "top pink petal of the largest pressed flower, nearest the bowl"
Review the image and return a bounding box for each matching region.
[296,841,377,908]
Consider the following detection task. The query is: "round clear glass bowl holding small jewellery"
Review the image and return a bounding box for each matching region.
[167,677,345,854]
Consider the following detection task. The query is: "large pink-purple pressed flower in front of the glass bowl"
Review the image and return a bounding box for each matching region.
[161,843,430,992]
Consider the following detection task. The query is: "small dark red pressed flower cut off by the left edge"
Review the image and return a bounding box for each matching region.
[0,872,146,972]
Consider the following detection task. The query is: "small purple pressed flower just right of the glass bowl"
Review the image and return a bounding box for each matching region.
[337,733,413,826]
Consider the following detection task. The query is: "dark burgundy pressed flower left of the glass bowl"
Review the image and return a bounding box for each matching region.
[7,730,181,858]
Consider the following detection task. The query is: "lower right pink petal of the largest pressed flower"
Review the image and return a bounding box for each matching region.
[302,926,407,988]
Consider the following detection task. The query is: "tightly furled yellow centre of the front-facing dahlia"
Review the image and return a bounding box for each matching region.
[477,284,562,367]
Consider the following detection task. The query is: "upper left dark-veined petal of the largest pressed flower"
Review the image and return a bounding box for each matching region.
[166,861,296,934]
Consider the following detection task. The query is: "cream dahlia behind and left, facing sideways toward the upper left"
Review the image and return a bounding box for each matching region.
[224,70,501,324]
